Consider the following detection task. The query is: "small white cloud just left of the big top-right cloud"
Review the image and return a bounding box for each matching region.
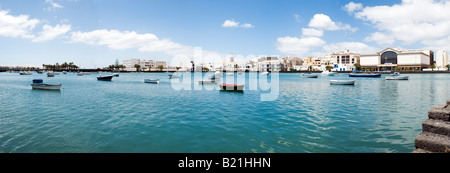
[308,14,357,32]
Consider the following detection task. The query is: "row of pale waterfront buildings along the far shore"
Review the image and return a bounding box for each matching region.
[123,48,450,71]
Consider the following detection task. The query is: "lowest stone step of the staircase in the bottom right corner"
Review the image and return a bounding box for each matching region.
[415,132,450,153]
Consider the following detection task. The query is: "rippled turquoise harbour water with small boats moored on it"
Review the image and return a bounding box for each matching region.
[0,73,450,153]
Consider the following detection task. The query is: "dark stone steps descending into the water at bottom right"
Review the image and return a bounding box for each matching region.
[413,100,450,153]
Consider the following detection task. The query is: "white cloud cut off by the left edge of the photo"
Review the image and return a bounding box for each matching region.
[0,11,40,38]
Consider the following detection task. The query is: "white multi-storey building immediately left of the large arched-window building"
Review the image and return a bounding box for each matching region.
[329,49,360,71]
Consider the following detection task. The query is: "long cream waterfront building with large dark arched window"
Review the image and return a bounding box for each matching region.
[360,48,434,71]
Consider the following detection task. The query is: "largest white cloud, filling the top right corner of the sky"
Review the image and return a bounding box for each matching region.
[354,0,450,48]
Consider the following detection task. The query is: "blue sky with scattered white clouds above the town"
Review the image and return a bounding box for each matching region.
[0,0,450,68]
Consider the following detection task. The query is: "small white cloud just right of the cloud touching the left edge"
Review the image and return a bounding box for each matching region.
[31,24,71,42]
